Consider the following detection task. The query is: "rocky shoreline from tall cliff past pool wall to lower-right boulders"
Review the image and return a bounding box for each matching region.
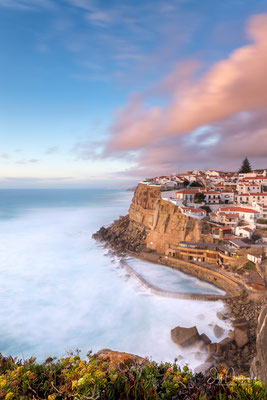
[93,183,267,380]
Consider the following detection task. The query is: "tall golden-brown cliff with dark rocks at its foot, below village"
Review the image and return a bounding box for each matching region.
[94,184,211,253]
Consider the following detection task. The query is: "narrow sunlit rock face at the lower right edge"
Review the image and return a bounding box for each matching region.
[250,304,267,382]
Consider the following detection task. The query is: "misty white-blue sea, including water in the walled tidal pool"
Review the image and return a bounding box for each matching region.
[0,189,229,368]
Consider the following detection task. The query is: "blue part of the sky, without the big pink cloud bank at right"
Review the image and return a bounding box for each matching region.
[0,0,267,187]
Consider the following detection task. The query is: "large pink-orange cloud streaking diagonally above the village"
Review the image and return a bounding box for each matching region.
[107,14,267,152]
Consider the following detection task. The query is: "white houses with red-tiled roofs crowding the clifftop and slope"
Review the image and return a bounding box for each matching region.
[139,162,267,290]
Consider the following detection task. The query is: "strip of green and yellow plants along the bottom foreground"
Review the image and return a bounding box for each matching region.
[0,354,267,400]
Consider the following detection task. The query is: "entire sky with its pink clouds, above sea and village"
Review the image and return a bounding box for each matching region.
[0,0,267,188]
